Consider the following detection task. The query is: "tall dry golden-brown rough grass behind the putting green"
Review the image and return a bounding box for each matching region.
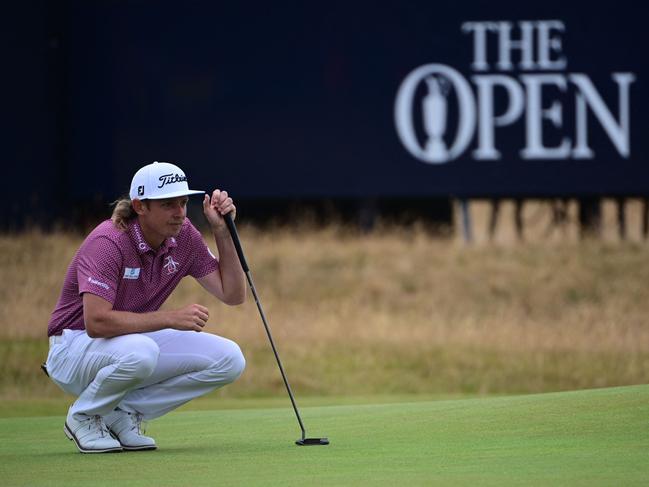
[0,199,649,397]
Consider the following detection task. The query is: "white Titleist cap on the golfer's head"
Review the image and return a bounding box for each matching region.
[129,161,205,200]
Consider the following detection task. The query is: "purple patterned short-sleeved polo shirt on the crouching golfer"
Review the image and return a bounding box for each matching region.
[47,218,219,336]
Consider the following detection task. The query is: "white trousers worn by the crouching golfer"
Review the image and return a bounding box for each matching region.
[47,329,246,420]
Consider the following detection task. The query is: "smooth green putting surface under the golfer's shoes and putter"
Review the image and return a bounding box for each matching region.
[0,386,649,487]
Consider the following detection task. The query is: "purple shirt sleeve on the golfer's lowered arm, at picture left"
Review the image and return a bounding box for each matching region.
[77,237,122,303]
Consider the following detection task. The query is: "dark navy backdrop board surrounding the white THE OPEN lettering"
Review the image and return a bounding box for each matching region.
[5,0,649,225]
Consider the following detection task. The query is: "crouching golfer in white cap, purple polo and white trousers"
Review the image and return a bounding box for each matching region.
[45,162,246,453]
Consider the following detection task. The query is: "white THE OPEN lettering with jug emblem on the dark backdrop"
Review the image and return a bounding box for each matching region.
[394,20,635,164]
